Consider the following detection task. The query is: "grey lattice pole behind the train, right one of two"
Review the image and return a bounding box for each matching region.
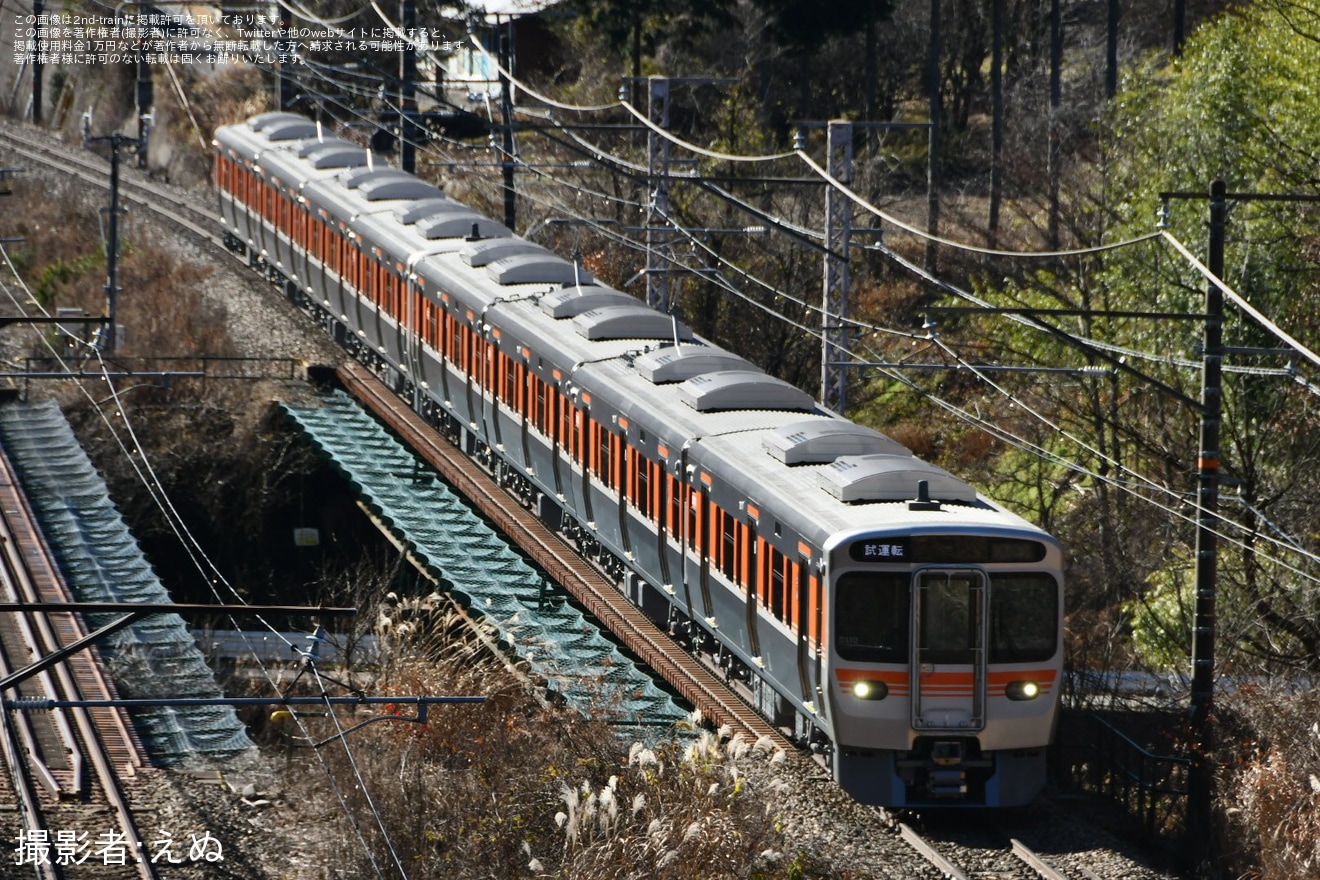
[821,120,853,414]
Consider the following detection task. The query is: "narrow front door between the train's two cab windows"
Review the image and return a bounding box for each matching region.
[912,569,987,734]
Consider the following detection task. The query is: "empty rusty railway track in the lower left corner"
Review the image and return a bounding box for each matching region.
[0,453,157,880]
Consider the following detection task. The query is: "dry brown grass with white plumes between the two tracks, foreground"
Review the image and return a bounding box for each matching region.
[275,612,820,880]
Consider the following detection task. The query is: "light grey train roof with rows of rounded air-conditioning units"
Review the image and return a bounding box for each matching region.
[216,113,1049,556]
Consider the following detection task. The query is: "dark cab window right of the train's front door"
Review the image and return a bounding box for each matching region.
[990,573,1059,664]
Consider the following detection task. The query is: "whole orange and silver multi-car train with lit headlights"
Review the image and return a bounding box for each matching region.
[215,113,1063,806]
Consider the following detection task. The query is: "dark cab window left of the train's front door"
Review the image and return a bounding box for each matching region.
[833,571,911,664]
